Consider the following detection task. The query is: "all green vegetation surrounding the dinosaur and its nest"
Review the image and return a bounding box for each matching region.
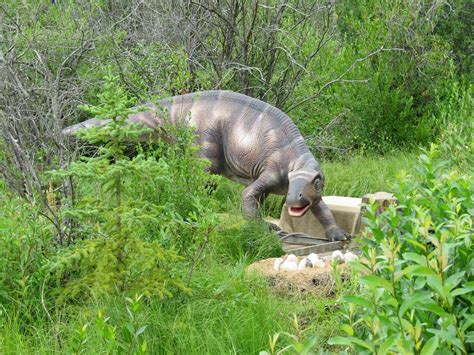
[0,0,474,354]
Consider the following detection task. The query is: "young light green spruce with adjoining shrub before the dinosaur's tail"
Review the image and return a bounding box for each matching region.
[48,76,218,300]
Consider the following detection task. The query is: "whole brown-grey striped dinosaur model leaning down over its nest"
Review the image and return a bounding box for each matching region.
[63,91,348,241]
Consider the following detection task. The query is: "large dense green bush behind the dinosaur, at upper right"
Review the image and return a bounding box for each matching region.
[292,1,462,156]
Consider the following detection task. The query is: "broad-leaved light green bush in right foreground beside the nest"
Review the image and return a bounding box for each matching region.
[330,141,474,354]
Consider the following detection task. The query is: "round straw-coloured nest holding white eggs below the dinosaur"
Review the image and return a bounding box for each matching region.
[247,251,357,297]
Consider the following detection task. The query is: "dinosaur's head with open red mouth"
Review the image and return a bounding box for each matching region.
[286,169,324,217]
